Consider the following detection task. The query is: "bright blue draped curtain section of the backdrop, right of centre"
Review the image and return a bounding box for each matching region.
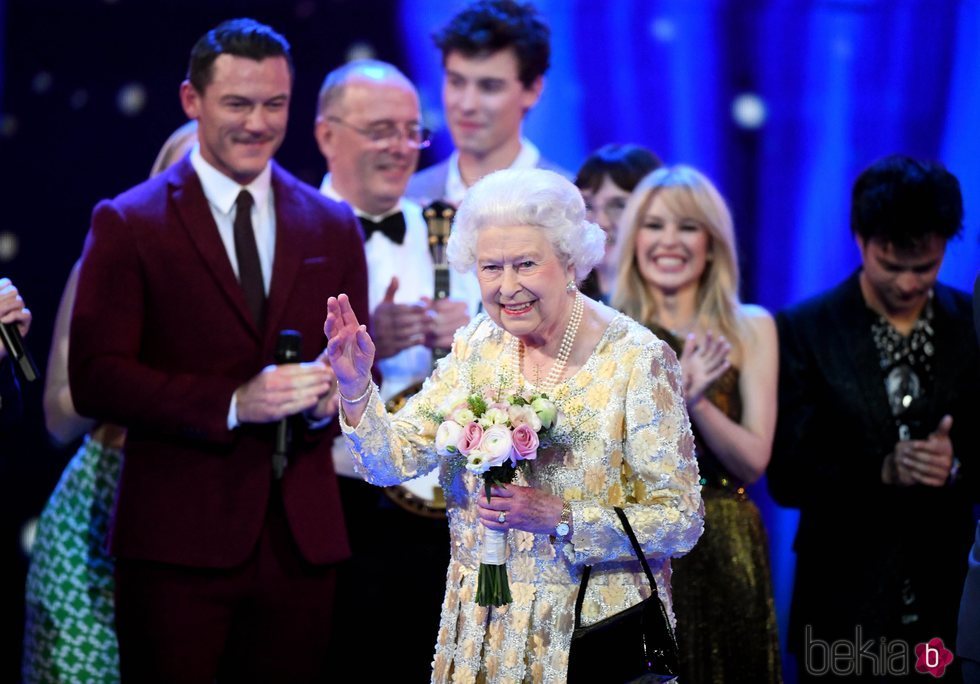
[401,0,980,676]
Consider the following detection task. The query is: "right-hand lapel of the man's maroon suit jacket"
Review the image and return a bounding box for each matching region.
[266,162,308,336]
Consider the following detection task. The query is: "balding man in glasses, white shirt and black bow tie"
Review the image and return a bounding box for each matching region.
[315,60,480,681]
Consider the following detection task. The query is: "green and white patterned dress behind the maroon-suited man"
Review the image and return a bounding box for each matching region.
[22,437,122,684]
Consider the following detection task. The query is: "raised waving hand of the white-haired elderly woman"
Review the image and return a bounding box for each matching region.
[323,294,374,397]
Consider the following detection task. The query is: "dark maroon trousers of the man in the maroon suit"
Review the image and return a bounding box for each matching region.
[116,485,336,684]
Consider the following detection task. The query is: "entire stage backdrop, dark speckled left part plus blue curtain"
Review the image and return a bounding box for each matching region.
[0,0,980,681]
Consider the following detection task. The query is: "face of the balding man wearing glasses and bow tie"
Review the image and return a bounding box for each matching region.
[316,79,420,214]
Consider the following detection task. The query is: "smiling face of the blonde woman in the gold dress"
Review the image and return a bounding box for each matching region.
[636,191,711,295]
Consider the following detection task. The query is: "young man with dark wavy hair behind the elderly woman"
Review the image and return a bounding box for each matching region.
[406,0,571,205]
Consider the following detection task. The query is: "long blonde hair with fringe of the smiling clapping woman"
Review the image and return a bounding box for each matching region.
[612,165,747,357]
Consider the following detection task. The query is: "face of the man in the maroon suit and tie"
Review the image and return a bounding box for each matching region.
[180,55,292,185]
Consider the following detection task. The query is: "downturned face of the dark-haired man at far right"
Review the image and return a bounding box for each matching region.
[857,233,946,318]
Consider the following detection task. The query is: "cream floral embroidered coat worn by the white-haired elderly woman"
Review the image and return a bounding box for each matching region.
[341,314,703,684]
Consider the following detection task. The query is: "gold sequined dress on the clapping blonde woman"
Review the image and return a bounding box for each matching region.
[651,325,782,684]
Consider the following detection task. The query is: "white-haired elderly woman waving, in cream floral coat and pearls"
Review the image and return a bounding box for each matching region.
[324,170,702,683]
